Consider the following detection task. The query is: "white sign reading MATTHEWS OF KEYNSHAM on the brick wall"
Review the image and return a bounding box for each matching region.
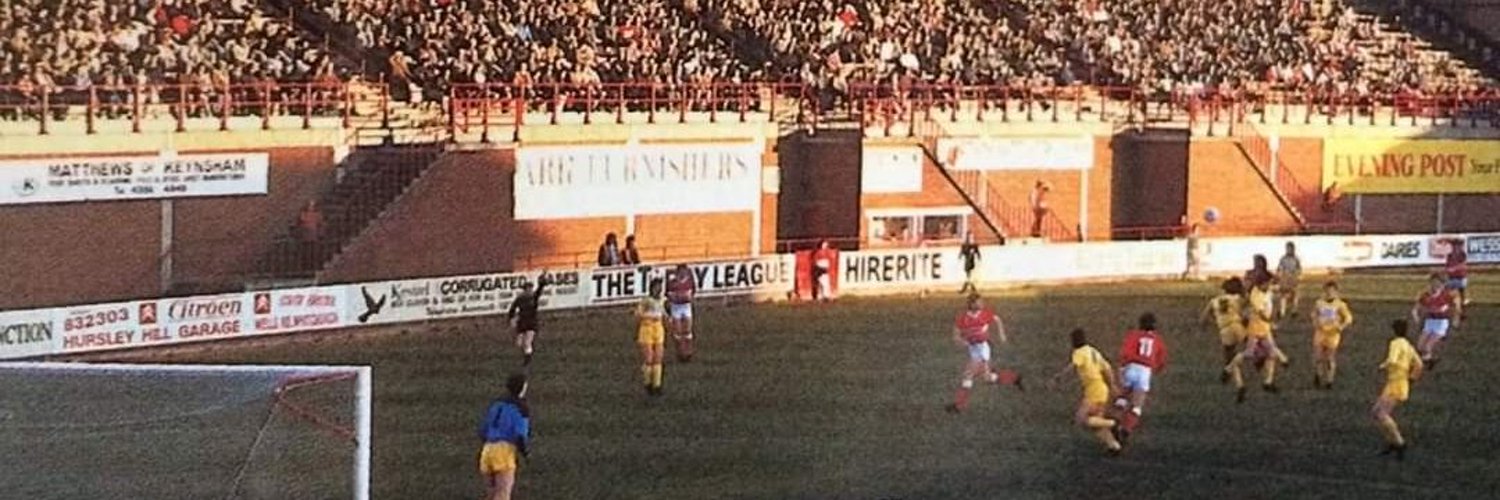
[0,153,270,204]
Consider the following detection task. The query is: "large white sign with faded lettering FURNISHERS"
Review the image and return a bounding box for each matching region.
[515,143,762,221]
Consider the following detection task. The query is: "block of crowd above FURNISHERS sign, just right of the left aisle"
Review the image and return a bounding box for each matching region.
[318,0,759,99]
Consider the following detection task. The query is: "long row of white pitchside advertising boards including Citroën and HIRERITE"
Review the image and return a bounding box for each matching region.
[0,229,1500,359]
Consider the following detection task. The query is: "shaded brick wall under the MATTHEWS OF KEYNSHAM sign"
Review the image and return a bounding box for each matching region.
[0,147,333,309]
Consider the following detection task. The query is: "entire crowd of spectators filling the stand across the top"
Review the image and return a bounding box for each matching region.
[0,0,1494,121]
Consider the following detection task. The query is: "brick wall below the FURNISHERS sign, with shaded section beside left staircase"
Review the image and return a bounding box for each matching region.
[324,141,777,282]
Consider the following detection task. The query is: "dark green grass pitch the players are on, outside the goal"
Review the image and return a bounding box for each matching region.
[126,272,1500,500]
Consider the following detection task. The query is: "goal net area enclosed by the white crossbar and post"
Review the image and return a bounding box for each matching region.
[0,363,371,500]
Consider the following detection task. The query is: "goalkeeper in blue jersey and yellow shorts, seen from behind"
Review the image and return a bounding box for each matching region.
[479,374,531,500]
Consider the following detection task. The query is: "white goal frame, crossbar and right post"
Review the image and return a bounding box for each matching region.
[0,362,372,500]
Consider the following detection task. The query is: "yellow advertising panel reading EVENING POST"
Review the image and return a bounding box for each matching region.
[1323,140,1500,194]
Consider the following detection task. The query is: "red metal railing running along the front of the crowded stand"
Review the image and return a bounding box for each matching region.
[0,81,1500,141]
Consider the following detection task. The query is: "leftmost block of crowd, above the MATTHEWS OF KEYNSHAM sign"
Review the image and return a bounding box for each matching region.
[0,0,341,119]
